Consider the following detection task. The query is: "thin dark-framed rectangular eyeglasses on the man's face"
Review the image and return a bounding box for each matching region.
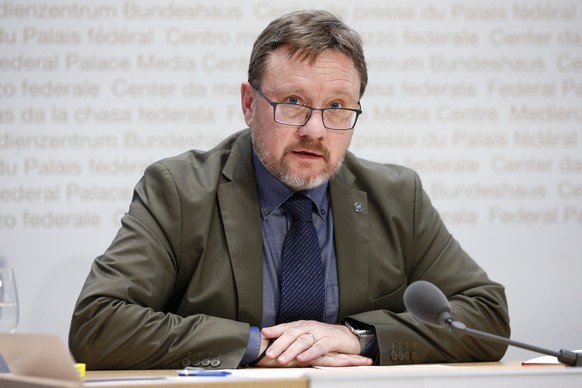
[254,85,362,131]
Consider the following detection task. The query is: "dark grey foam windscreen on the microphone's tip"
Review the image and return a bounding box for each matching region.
[404,280,451,325]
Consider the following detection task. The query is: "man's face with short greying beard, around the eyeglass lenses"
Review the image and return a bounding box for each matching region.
[241,46,360,191]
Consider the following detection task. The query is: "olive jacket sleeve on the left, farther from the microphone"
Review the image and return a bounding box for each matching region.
[69,163,249,369]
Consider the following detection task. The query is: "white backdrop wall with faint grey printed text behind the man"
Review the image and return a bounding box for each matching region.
[0,0,582,359]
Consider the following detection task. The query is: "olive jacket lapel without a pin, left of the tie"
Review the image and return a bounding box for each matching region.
[218,132,263,327]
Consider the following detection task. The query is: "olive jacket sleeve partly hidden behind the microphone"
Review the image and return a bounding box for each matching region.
[350,172,510,365]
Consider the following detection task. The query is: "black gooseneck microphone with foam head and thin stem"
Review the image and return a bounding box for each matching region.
[404,280,582,366]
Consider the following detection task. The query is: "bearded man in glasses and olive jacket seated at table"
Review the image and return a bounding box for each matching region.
[69,11,509,369]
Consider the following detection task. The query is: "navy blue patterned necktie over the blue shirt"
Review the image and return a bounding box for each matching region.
[277,193,325,323]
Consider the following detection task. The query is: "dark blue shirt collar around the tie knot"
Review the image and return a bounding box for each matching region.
[253,150,329,219]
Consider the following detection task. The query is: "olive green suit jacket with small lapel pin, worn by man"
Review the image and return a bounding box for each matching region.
[69,129,509,369]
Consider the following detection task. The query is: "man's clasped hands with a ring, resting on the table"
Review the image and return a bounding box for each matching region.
[257,321,372,367]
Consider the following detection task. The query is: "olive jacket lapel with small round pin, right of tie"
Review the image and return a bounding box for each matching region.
[330,167,372,322]
